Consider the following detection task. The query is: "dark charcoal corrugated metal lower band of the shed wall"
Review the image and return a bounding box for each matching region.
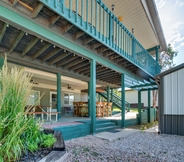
[160,115,184,136]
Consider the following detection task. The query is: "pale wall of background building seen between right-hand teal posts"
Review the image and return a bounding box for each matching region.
[125,90,158,106]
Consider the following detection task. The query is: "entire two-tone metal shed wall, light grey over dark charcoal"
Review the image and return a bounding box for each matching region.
[159,68,184,136]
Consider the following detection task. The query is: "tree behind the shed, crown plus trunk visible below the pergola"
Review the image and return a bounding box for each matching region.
[152,44,178,108]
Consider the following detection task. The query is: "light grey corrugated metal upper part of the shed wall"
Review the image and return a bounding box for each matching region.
[163,69,184,115]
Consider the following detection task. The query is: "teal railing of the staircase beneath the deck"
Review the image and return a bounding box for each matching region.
[98,91,130,111]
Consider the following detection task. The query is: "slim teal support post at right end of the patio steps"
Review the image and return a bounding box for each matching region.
[121,74,125,128]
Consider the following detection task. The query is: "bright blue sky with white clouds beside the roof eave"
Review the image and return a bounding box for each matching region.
[155,0,184,65]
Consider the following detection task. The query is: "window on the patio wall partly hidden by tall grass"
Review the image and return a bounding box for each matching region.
[27,91,40,105]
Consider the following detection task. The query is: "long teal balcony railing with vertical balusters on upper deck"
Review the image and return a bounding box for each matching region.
[39,0,160,76]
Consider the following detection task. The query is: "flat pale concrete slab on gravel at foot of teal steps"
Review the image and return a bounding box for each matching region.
[94,129,140,141]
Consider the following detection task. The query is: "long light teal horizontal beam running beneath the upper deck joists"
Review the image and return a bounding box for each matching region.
[0,5,146,81]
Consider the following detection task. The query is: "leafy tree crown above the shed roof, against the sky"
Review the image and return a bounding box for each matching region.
[159,44,178,69]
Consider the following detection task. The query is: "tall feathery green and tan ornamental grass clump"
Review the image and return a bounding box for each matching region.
[0,60,40,162]
